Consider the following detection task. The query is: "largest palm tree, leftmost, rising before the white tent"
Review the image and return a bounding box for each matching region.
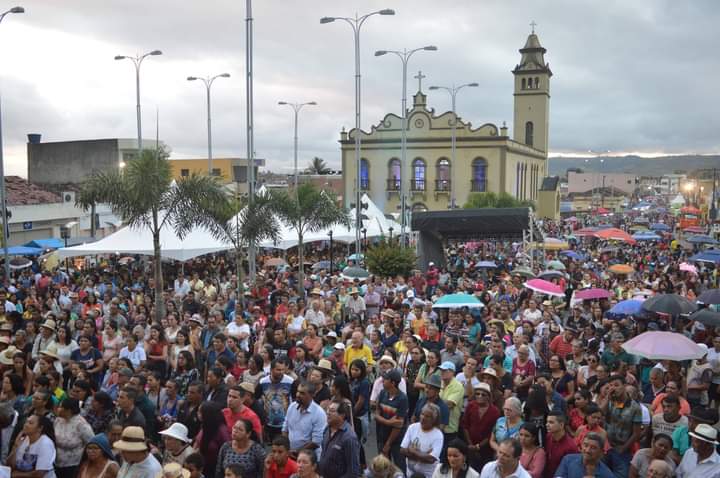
[76,149,227,323]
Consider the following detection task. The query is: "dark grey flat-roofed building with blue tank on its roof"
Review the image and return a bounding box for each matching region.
[27,134,164,190]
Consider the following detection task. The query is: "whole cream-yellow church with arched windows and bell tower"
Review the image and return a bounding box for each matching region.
[340,31,552,214]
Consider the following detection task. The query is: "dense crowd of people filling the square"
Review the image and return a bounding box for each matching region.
[0,216,720,478]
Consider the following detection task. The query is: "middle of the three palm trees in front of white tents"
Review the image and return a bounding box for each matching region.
[206,193,280,297]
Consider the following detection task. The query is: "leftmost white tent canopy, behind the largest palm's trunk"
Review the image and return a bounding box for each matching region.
[58,218,233,261]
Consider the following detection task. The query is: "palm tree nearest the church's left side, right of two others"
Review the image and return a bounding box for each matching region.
[272,183,350,296]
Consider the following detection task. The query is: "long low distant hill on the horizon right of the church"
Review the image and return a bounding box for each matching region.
[549,155,720,176]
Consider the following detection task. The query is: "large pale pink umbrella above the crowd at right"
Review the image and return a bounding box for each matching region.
[622,331,707,361]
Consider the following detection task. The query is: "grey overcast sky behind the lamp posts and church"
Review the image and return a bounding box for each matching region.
[0,0,720,176]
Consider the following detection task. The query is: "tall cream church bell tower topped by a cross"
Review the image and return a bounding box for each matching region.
[512,22,552,153]
